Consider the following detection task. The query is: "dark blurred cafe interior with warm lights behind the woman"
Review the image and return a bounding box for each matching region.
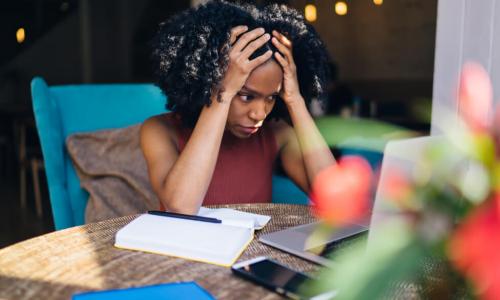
[0,0,437,248]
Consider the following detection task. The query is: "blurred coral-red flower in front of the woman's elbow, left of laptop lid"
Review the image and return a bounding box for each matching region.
[311,156,373,225]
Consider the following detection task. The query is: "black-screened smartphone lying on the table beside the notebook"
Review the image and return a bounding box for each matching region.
[231,256,336,299]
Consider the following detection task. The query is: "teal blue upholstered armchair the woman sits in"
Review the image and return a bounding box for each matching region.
[31,77,307,230]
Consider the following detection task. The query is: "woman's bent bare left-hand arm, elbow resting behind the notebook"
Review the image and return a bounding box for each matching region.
[141,99,230,214]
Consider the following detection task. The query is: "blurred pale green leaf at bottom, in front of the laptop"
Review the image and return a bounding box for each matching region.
[306,220,425,299]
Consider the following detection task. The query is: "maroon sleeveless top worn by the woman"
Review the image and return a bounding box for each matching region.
[161,114,278,205]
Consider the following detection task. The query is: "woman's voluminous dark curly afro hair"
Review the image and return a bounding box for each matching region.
[152,0,329,128]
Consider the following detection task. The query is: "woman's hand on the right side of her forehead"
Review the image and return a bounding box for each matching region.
[272,30,304,106]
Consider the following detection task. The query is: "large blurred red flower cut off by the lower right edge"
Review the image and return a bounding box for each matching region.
[449,193,500,299]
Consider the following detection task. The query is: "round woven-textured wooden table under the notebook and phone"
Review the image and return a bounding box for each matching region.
[0,204,318,299]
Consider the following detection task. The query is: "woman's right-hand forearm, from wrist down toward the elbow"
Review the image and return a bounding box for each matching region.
[288,99,335,182]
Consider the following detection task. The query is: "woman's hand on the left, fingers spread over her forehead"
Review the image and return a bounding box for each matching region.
[221,26,273,98]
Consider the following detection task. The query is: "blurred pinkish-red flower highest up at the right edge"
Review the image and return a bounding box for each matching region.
[458,62,493,131]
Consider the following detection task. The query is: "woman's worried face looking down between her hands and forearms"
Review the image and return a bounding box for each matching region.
[226,59,283,138]
